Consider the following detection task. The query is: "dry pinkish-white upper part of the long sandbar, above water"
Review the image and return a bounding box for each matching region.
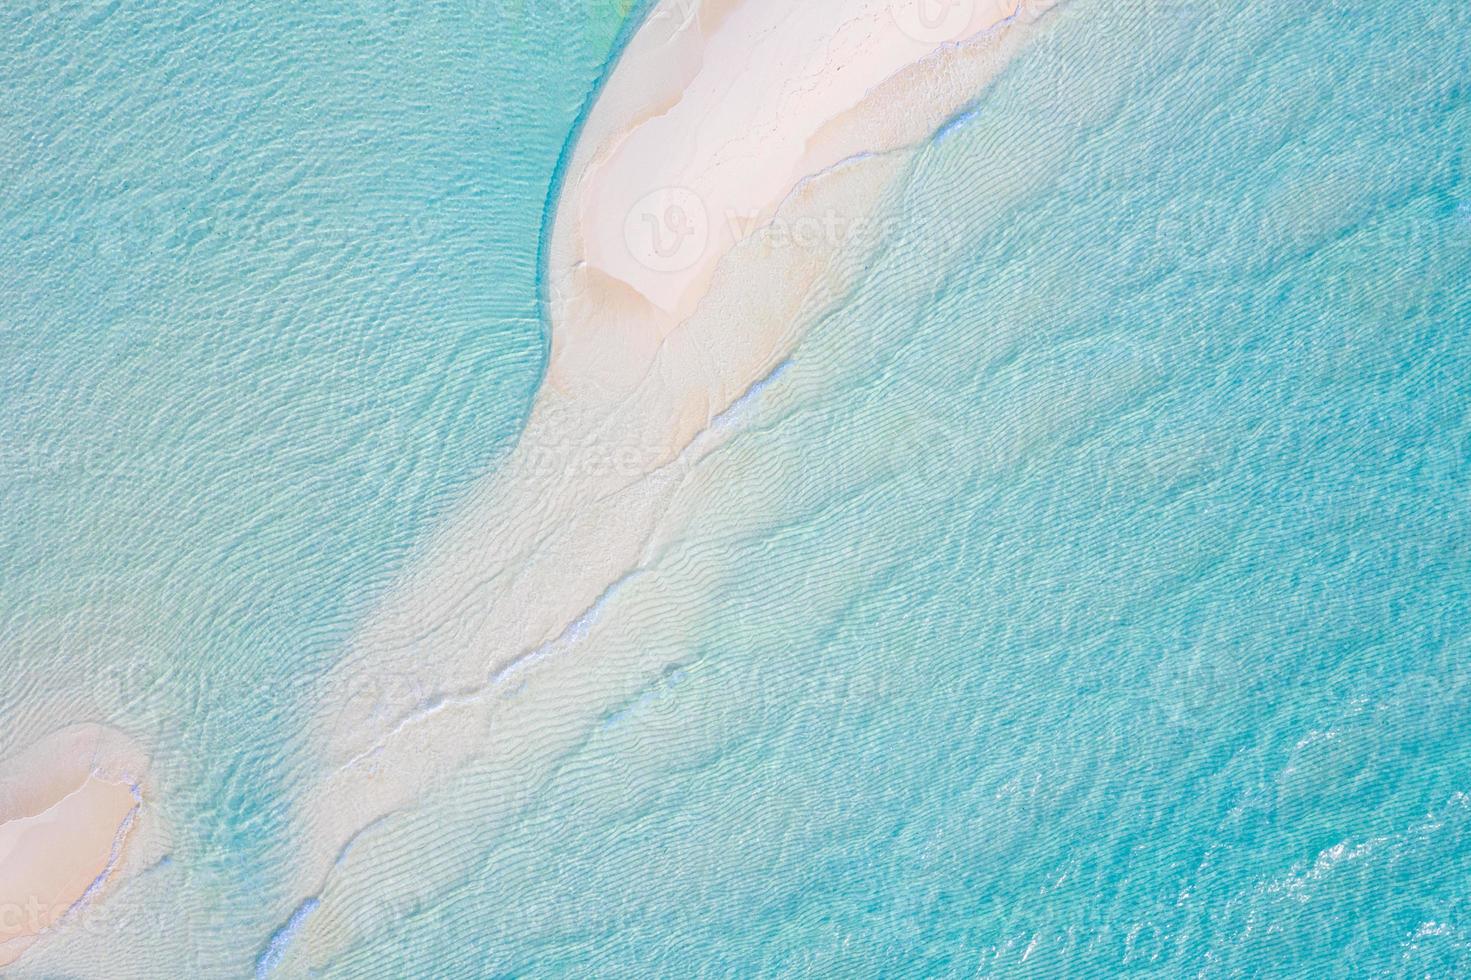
[562,0,1019,319]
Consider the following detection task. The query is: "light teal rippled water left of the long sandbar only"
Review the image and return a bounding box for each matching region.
[0,0,612,970]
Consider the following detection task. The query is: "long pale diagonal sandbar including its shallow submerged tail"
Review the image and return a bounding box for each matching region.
[292,0,1050,962]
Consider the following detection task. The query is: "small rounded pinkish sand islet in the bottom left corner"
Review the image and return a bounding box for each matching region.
[0,725,147,967]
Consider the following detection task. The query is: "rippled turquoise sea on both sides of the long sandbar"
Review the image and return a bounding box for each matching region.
[0,0,1471,977]
